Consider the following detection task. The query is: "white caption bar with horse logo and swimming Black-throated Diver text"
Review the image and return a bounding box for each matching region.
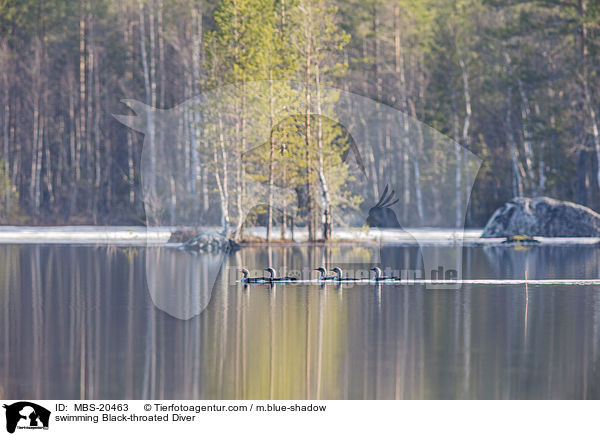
[0,400,599,436]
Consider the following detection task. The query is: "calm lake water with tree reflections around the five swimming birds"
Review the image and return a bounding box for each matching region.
[0,245,600,399]
